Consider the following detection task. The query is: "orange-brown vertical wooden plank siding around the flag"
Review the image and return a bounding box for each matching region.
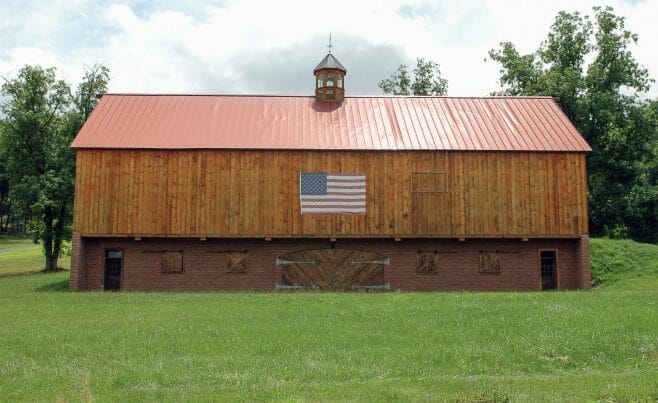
[74,150,587,237]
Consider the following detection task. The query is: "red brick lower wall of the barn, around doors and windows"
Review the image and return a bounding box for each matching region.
[71,234,591,291]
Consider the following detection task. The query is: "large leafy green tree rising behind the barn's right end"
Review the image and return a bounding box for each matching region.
[489,7,658,241]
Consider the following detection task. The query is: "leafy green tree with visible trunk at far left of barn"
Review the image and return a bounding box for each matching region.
[2,66,73,271]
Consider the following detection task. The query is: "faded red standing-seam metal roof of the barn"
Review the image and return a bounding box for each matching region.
[73,94,591,152]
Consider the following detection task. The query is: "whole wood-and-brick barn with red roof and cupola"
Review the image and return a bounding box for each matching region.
[70,53,591,290]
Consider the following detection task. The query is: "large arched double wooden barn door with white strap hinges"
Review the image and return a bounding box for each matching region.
[277,249,389,291]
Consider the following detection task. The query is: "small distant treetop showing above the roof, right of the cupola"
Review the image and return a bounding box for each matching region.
[377,58,448,95]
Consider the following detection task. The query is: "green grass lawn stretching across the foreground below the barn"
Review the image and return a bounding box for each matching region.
[0,240,658,401]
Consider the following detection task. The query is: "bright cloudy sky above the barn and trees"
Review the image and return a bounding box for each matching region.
[0,0,658,98]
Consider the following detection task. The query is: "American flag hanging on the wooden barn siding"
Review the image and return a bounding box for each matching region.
[299,172,366,214]
